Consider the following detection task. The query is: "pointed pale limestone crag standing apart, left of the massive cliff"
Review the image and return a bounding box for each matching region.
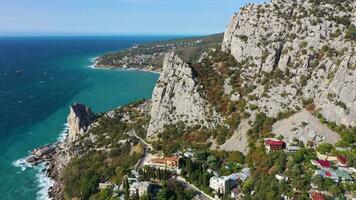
[147,53,217,136]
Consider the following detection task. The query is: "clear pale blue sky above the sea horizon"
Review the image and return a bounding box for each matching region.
[0,0,262,36]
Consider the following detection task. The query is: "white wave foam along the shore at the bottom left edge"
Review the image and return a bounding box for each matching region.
[36,164,54,200]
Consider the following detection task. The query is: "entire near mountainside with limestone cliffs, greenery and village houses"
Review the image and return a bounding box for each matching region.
[28,0,356,200]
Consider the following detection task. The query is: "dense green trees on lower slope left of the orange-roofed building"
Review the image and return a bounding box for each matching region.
[61,145,140,199]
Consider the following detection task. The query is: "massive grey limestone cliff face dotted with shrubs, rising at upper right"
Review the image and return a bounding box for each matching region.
[222,0,356,126]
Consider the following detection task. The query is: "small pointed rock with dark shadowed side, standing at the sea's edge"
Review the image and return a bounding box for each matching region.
[67,103,96,142]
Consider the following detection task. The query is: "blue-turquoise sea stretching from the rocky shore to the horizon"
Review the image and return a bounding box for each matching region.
[0,36,177,200]
